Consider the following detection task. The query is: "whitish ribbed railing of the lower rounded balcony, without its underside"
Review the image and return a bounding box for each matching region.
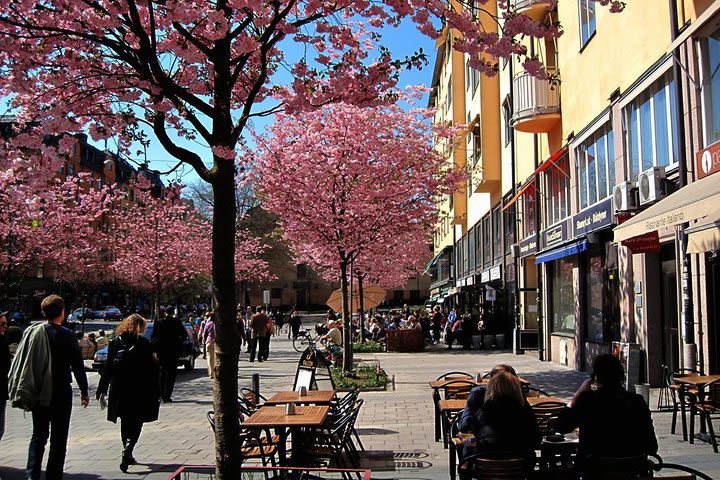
[512,67,560,124]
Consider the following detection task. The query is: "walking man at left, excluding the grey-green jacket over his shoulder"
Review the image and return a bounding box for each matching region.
[25,295,90,480]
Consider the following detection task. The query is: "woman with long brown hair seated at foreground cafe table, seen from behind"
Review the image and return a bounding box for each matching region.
[460,370,542,480]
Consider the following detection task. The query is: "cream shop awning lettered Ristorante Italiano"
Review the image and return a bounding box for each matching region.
[614,174,720,243]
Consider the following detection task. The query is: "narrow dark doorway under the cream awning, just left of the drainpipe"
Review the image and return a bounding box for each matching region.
[660,244,680,370]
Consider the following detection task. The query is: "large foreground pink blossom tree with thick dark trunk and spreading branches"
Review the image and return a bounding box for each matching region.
[0,0,620,472]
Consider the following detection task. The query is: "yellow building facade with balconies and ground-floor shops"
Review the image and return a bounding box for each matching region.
[436,0,720,385]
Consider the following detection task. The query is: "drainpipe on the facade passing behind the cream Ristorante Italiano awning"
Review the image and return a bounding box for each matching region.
[669,0,697,368]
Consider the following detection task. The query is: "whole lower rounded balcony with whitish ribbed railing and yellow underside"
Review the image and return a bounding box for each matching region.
[510,67,560,133]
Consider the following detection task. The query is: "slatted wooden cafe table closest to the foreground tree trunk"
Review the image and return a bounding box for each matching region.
[242,405,330,465]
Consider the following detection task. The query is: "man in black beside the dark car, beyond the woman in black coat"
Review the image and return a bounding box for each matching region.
[150,311,187,402]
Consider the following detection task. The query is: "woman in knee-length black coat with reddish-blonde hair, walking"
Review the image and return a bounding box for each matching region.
[95,314,160,472]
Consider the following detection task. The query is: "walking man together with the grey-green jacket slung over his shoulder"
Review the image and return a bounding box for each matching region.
[8,295,90,480]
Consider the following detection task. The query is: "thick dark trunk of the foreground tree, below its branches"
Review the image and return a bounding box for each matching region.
[212,159,242,480]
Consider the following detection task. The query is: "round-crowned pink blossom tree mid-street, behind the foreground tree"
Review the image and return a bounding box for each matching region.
[255,103,459,370]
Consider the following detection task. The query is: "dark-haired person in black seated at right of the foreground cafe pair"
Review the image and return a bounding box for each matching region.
[555,354,658,470]
